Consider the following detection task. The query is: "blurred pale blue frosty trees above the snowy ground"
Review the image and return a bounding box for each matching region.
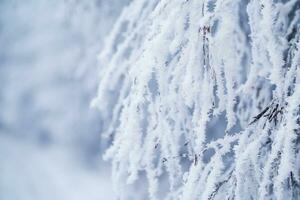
[0,0,128,159]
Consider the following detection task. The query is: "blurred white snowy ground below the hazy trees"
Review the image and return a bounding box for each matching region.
[0,135,113,200]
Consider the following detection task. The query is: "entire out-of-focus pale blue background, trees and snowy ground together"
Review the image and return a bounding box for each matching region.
[0,0,129,200]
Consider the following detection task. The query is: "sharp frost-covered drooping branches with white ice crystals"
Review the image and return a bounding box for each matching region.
[92,0,300,200]
